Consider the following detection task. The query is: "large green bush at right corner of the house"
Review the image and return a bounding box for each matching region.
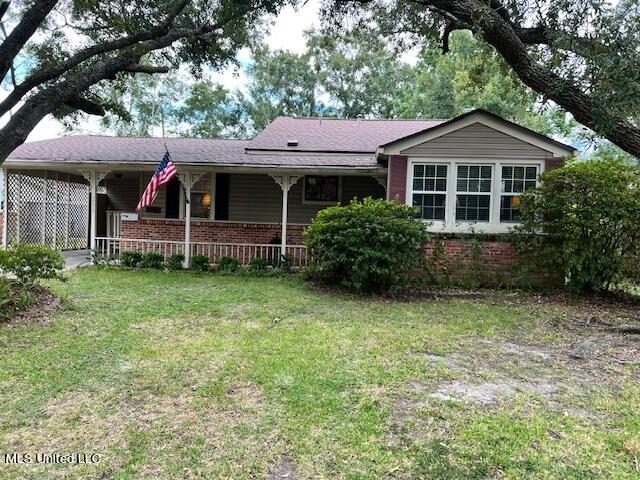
[516,158,640,292]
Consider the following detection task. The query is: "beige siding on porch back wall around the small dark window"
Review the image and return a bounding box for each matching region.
[229,174,384,224]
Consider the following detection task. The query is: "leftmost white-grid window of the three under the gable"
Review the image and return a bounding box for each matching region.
[412,164,448,221]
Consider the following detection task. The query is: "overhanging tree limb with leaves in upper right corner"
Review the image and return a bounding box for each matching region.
[323,0,640,157]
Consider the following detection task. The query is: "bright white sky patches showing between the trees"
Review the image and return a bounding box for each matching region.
[22,0,320,142]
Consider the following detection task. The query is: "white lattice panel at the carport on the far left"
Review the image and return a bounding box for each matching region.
[7,172,89,250]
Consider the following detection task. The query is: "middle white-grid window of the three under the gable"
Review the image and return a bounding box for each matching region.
[456,165,492,222]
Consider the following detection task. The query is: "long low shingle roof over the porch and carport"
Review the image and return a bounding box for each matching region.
[8,135,377,167]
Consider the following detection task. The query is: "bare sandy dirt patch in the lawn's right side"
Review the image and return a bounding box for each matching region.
[390,331,640,437]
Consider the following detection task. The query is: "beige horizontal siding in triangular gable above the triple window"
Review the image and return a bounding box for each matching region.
[401,123,552,160]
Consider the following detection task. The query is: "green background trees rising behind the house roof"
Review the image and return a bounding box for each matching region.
[97,31,566,137]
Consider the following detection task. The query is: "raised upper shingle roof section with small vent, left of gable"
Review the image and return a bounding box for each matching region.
[247,117,445,152]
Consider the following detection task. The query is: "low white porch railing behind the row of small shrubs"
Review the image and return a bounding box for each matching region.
[94,237,307,267]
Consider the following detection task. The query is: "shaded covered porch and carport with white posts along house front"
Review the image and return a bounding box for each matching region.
[2,162,386,266]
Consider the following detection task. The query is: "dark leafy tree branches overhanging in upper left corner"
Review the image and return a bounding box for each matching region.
[0,0,294,162]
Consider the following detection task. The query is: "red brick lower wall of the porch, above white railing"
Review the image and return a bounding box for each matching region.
[121,219,304,245]
